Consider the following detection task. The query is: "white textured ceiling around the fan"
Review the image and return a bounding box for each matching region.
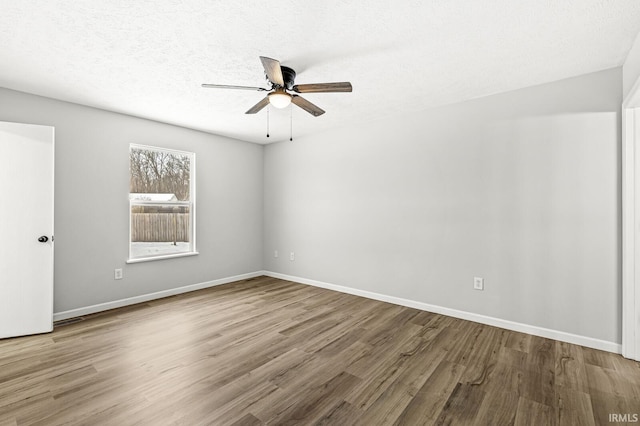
[0,0,640,143]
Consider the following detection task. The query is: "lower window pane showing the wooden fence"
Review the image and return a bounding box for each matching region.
[131,204,193,258]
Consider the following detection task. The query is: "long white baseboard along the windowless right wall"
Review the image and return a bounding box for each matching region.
[263,271,622,354]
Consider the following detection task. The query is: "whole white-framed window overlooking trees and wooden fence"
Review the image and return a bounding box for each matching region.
[129,145,197,263]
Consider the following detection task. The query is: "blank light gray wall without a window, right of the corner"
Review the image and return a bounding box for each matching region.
[264,68,622,342]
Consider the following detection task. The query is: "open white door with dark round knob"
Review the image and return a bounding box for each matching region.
[0,122,54,338]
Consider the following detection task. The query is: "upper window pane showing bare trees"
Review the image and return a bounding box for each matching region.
[129,147,191,202]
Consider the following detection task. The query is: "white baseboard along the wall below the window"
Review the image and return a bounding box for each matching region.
[53,271,265,321]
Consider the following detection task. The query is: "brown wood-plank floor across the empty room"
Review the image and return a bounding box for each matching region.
[0,277,640,426]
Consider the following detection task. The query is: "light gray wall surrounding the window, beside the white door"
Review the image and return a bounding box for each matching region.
[0,89,263,312]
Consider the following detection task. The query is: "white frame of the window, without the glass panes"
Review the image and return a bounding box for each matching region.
[127,144,198,263]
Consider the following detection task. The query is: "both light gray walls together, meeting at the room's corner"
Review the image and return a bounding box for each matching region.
[0,69,622,342]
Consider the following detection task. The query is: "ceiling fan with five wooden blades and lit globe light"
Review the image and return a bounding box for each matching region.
[202,56,352,117]
